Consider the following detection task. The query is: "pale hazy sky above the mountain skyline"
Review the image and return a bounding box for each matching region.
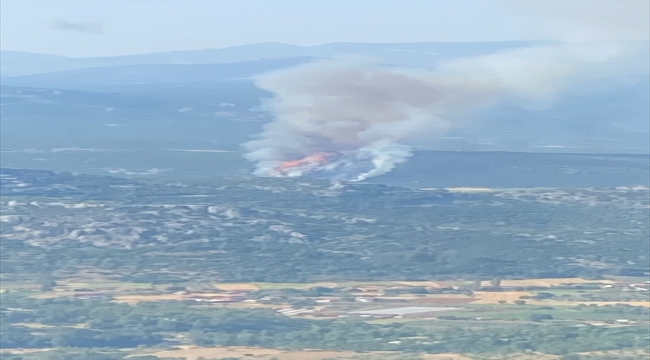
[0,0,650,56]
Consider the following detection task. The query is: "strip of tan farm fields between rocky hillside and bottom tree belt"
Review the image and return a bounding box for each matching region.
[15,278,650,307]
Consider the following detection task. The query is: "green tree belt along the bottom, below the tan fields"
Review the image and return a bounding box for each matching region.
[0,295,650,355]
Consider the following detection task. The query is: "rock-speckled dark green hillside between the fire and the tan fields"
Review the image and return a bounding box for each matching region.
[0,169,650,283]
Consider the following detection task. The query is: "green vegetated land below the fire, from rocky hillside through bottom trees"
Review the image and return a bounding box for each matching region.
[0,169,650,360]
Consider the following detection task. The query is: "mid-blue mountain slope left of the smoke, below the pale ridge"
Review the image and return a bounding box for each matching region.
[0,82,265,149]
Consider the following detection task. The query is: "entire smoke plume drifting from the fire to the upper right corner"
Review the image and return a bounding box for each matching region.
[244,1,649,181]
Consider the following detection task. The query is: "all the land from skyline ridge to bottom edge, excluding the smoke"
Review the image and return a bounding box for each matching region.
[0,41,650,360]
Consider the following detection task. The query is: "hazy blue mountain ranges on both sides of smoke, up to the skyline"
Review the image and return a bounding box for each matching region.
[0,42,650,153]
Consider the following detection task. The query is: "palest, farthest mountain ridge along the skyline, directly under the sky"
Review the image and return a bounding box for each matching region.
[0,41,542,76]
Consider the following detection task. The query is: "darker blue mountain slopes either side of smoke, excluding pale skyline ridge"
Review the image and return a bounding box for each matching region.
[0,73,650,153]
